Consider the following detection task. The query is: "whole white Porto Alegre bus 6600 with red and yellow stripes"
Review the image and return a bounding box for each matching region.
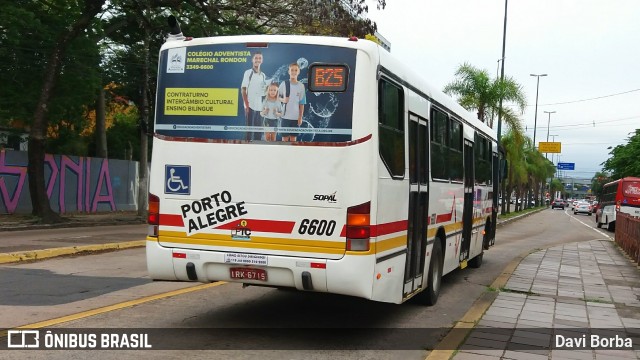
[146,28,498,305]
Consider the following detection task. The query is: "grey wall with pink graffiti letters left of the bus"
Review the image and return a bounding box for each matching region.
[0,150,138,214]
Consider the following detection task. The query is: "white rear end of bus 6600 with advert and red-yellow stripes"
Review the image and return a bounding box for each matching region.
[147,36,377,298]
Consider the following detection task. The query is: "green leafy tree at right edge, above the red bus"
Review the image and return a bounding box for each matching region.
[602,129,640,180]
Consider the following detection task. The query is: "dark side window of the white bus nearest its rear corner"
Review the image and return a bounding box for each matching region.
[378,79,405,179]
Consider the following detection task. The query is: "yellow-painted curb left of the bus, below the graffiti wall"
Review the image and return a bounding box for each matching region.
[0,240,146,264]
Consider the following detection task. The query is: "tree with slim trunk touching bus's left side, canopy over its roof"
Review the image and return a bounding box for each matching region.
[100,0,385,216]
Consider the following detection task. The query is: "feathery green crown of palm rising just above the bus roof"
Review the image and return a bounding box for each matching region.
[444,63,527,133]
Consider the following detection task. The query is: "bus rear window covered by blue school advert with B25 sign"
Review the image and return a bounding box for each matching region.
[154,43,356,142]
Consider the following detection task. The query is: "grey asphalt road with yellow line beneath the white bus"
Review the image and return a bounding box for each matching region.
[0,209,612,360]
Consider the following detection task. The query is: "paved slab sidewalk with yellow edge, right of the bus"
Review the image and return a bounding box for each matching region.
[427,240,640,360]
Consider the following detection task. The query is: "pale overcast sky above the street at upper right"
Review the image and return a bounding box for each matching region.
[368,0,640,178]
